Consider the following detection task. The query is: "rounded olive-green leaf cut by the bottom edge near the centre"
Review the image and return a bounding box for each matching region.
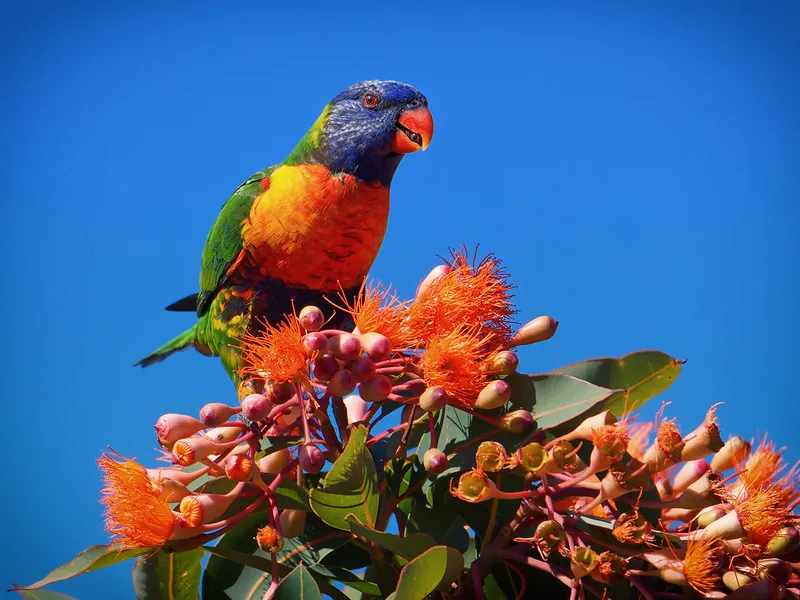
[395,546,464,600]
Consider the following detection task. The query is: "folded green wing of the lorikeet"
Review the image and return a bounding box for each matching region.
[197,166,277,316]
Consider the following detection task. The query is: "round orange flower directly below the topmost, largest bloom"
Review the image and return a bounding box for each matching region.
[419,327,490,405]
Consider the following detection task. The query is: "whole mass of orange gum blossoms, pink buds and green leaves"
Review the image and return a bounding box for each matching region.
[16,252,800,600]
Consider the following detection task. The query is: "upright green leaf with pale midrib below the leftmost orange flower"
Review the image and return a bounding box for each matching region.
[133,548,205,600]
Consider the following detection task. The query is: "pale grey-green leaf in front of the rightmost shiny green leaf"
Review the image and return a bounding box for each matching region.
[506,373,619,429]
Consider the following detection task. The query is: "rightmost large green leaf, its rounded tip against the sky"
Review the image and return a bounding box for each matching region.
[557,350,685,417]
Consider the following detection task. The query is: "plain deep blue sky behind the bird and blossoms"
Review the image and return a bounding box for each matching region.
[0,1,800,599]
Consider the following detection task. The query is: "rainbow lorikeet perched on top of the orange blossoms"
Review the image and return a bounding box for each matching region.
[137,81,433,380]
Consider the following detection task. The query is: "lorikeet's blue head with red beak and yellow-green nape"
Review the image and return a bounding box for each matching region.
[289,80,433,187]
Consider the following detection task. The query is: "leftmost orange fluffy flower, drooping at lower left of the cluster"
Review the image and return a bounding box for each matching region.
[97,453,175,548]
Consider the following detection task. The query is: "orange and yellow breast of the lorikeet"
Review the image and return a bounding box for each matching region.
[242,165,389,291]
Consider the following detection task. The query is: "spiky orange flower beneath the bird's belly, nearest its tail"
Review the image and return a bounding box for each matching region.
[239,315,313,383]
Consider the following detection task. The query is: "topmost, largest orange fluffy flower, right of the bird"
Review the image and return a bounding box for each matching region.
[409,249,516,346]
